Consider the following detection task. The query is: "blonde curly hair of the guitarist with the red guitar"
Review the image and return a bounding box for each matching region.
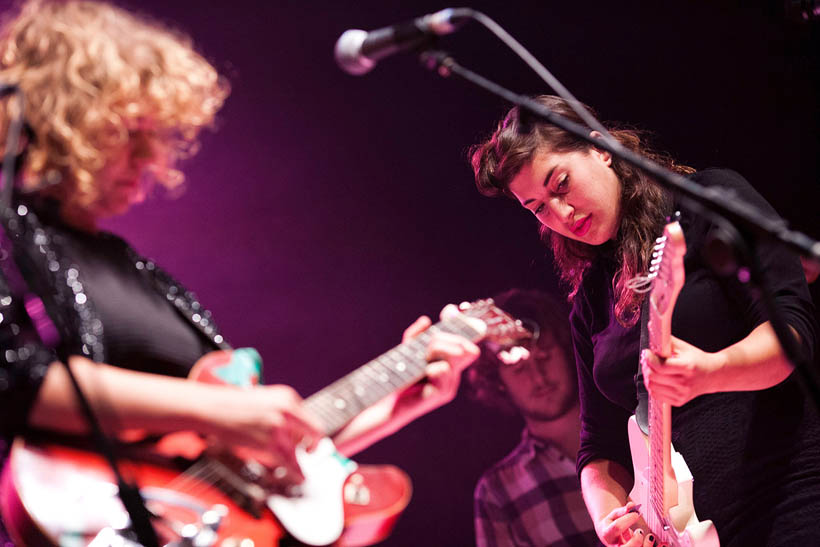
[0,0,229,213]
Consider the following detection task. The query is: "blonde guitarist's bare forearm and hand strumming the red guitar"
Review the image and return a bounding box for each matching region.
[29,356,322,484]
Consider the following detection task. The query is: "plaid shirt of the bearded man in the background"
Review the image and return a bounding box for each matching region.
[474,428,600,547]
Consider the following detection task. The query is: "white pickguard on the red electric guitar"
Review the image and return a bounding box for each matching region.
[268,438,357,545]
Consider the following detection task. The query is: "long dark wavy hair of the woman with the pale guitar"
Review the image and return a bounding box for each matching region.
[469,95,694,327]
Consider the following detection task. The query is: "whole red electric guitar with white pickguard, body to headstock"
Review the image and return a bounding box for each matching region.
[0,300,530,547]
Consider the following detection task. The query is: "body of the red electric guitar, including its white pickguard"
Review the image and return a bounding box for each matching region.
[0,349,412,547]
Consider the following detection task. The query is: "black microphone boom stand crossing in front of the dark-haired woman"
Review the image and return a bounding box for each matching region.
[421,50,820,410]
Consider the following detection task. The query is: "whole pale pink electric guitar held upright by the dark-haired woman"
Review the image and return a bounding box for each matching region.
[629,222,719,547]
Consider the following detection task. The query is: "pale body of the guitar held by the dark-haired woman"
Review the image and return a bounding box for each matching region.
[628,416,720,547]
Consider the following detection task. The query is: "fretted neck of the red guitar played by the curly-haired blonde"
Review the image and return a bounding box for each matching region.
[304,316,483,435]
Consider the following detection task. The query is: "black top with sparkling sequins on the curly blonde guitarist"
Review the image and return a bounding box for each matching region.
[0,200,229,546]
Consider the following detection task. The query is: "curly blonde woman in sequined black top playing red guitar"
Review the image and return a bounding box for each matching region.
[0,0,478,543]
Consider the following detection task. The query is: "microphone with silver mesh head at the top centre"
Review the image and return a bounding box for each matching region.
[334,8,471,76]
